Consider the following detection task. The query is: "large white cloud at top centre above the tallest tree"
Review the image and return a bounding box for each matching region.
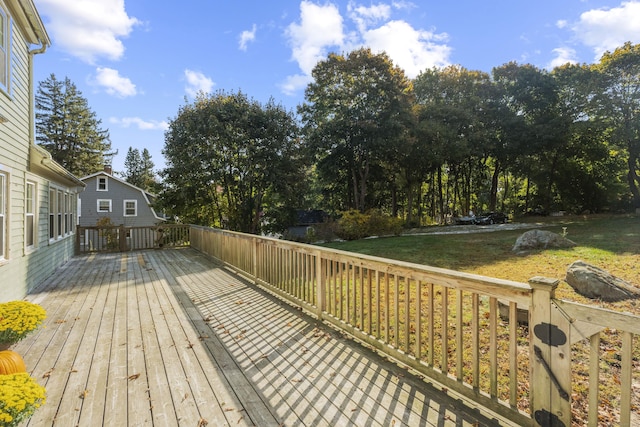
[280,0,451,95]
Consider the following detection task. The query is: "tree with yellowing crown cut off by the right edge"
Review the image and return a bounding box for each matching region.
[595,42,640,209]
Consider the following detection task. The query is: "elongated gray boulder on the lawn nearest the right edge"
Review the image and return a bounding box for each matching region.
[565,261,640,302]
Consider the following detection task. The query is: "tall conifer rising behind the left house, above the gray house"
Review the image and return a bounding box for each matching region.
[35,74,111,176]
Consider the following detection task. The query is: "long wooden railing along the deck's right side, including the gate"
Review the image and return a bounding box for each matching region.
[190,226,640,426]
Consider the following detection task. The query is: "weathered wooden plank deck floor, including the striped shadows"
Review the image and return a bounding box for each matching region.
[14,249,516,427]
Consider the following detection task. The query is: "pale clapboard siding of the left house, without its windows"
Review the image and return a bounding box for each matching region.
[0,3,82,301]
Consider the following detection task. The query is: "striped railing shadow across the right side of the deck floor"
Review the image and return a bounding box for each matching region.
[159,251,512,426]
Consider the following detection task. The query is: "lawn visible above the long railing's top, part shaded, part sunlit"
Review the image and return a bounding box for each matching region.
[323,215,640,314]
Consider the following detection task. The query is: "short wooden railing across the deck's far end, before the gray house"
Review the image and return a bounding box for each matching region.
[76,224,190,254]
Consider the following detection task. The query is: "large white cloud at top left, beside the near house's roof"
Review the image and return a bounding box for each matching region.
[38,0,140,64]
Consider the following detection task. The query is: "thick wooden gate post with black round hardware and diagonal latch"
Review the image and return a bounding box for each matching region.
[529,277,571,427]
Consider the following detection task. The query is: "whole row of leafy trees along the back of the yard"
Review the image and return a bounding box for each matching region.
[162,43,640,232]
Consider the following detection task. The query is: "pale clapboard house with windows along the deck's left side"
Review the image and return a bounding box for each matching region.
[0,0,83,301]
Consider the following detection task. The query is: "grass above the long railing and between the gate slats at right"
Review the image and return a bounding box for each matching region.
[323,215,640,425]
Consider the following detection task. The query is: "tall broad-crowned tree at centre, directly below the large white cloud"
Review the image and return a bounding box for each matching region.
[298,49,412,211]
